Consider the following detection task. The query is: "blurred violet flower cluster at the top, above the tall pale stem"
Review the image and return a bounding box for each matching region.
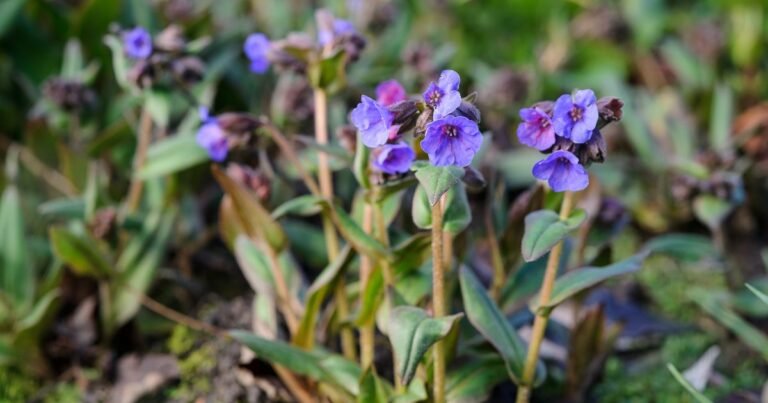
[243,10,365,74]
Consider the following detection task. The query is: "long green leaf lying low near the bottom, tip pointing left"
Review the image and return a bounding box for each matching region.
[229,330,363,396]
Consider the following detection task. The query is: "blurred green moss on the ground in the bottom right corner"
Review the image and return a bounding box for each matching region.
[594,333,764,403]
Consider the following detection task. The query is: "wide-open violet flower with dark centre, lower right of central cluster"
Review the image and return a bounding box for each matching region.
[421,116,483,167]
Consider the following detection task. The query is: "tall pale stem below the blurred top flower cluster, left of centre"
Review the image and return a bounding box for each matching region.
[314,88,357,360]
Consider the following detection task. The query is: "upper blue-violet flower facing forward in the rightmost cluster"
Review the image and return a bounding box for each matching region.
[552,90,598,144]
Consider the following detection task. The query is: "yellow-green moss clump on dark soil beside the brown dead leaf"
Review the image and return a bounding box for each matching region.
[168,325,216,401]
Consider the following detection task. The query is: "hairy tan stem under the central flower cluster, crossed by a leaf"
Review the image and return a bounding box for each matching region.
[432,195,447,403]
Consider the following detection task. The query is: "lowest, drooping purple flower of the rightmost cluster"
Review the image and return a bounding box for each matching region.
[533,150,589,192]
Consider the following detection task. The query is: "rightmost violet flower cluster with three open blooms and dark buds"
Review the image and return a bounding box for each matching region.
[517,89,623,192]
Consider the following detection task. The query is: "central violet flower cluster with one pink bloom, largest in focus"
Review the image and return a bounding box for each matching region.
[350,70,483,174]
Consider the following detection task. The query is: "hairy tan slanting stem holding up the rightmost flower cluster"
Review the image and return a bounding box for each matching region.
[517,192,573,403]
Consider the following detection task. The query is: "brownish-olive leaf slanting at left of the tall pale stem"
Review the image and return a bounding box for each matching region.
[212,166,287,252]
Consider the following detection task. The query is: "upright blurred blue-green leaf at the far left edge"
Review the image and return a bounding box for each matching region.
[0,184,34,308]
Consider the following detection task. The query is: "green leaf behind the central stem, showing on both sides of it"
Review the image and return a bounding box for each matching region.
[411,183,472,234]
